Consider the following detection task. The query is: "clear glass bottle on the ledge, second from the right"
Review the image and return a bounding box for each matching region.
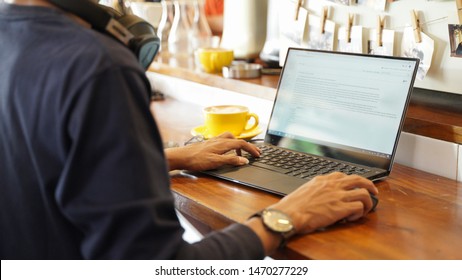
[168,0,192,56]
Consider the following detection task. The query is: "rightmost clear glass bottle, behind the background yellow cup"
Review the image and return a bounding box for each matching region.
[189,0,212,50]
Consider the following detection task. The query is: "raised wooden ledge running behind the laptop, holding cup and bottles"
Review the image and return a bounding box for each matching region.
[150,57,462,144]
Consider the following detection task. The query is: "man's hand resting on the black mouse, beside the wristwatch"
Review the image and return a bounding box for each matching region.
[271,172,378,233]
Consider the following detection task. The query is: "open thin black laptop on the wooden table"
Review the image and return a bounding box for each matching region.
[205,48,419,195]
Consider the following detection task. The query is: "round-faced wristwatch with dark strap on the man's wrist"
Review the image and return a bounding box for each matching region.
[251,208,295,248]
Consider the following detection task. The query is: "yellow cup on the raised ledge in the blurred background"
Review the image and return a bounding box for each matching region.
[196,48,234,73]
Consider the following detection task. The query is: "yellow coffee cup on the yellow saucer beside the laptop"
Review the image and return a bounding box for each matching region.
[204,105,258,137]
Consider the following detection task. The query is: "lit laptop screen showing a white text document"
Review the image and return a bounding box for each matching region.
[265,48,418,169]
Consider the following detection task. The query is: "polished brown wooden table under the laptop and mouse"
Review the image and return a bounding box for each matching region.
[151,94,462,260]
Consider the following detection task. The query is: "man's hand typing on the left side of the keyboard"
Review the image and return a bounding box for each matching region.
[165,132,260,171]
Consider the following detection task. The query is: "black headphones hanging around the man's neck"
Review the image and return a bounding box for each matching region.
[49,0,160,69]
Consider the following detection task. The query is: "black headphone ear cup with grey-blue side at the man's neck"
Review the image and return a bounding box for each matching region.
[117,15,160,69]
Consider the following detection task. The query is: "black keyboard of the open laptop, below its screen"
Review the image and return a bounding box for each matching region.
[244,145,370,179]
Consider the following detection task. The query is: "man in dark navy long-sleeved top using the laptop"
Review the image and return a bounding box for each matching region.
[0,0,377,259]
